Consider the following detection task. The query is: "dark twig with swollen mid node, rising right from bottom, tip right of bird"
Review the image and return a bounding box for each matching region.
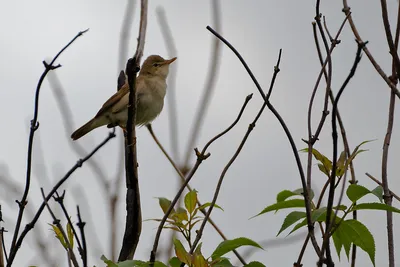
[149,95,252,264]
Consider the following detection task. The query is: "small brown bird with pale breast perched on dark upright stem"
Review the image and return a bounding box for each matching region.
[71,55,176,140]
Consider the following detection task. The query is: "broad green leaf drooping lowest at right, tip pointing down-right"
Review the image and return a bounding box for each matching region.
[339,219,375,266]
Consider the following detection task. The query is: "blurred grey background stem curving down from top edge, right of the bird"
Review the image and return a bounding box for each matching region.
[183,0,222,169]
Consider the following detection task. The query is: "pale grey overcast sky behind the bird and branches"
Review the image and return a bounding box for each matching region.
[0,0,400,266]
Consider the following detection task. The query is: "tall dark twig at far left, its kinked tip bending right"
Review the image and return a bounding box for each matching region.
[10,29,89,257]
